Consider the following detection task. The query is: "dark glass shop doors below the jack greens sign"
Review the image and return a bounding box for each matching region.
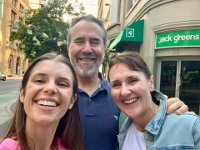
[158,59,200,114]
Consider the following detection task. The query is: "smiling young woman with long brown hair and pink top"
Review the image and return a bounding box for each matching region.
[0,52,84,150]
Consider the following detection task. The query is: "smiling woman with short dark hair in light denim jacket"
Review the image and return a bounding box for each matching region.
[108,51,200,150]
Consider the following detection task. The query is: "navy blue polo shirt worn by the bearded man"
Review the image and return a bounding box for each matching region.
[79,74,119,150]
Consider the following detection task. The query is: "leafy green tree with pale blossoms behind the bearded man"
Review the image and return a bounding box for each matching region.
[10,0,84,61]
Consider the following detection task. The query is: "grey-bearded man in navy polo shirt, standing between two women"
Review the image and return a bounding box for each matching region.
[65,15,188,150]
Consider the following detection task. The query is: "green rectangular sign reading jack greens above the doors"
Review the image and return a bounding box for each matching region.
[156,30,200,49]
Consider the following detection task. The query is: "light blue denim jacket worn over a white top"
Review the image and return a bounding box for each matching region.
[117,91,200,150]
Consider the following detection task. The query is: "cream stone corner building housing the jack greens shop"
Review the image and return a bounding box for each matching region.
[98,0,200,114]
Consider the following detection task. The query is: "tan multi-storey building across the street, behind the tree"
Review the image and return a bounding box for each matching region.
[0,0,30,76]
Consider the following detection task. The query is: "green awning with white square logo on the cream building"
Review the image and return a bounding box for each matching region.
[109,20,144,50]
